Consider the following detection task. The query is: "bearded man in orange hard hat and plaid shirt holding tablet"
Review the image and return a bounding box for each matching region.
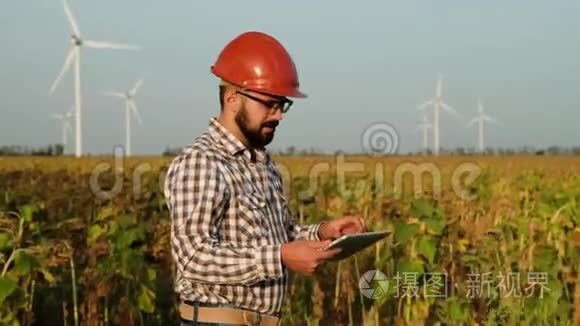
[165,32,364,325]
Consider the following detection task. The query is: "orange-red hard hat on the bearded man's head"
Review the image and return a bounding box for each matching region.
[211,32,306,97]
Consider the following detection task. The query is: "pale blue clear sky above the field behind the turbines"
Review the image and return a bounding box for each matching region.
[0,0,580,154]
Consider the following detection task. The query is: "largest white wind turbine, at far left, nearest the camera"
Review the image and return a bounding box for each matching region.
[50,0,139,157]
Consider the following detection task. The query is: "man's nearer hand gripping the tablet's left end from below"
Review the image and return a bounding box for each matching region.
[280,240,340,276]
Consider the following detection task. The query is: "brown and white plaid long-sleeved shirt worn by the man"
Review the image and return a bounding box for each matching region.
[165,118,320,314]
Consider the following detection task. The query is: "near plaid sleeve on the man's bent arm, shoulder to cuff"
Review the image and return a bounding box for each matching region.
[165,151,284,285]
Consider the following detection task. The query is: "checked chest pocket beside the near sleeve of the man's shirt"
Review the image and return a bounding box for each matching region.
[237,193,268,239]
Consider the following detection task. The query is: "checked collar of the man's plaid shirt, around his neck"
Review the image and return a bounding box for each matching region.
[209,117,269,162]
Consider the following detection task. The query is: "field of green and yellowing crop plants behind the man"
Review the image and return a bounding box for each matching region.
[0,156,580,325]
